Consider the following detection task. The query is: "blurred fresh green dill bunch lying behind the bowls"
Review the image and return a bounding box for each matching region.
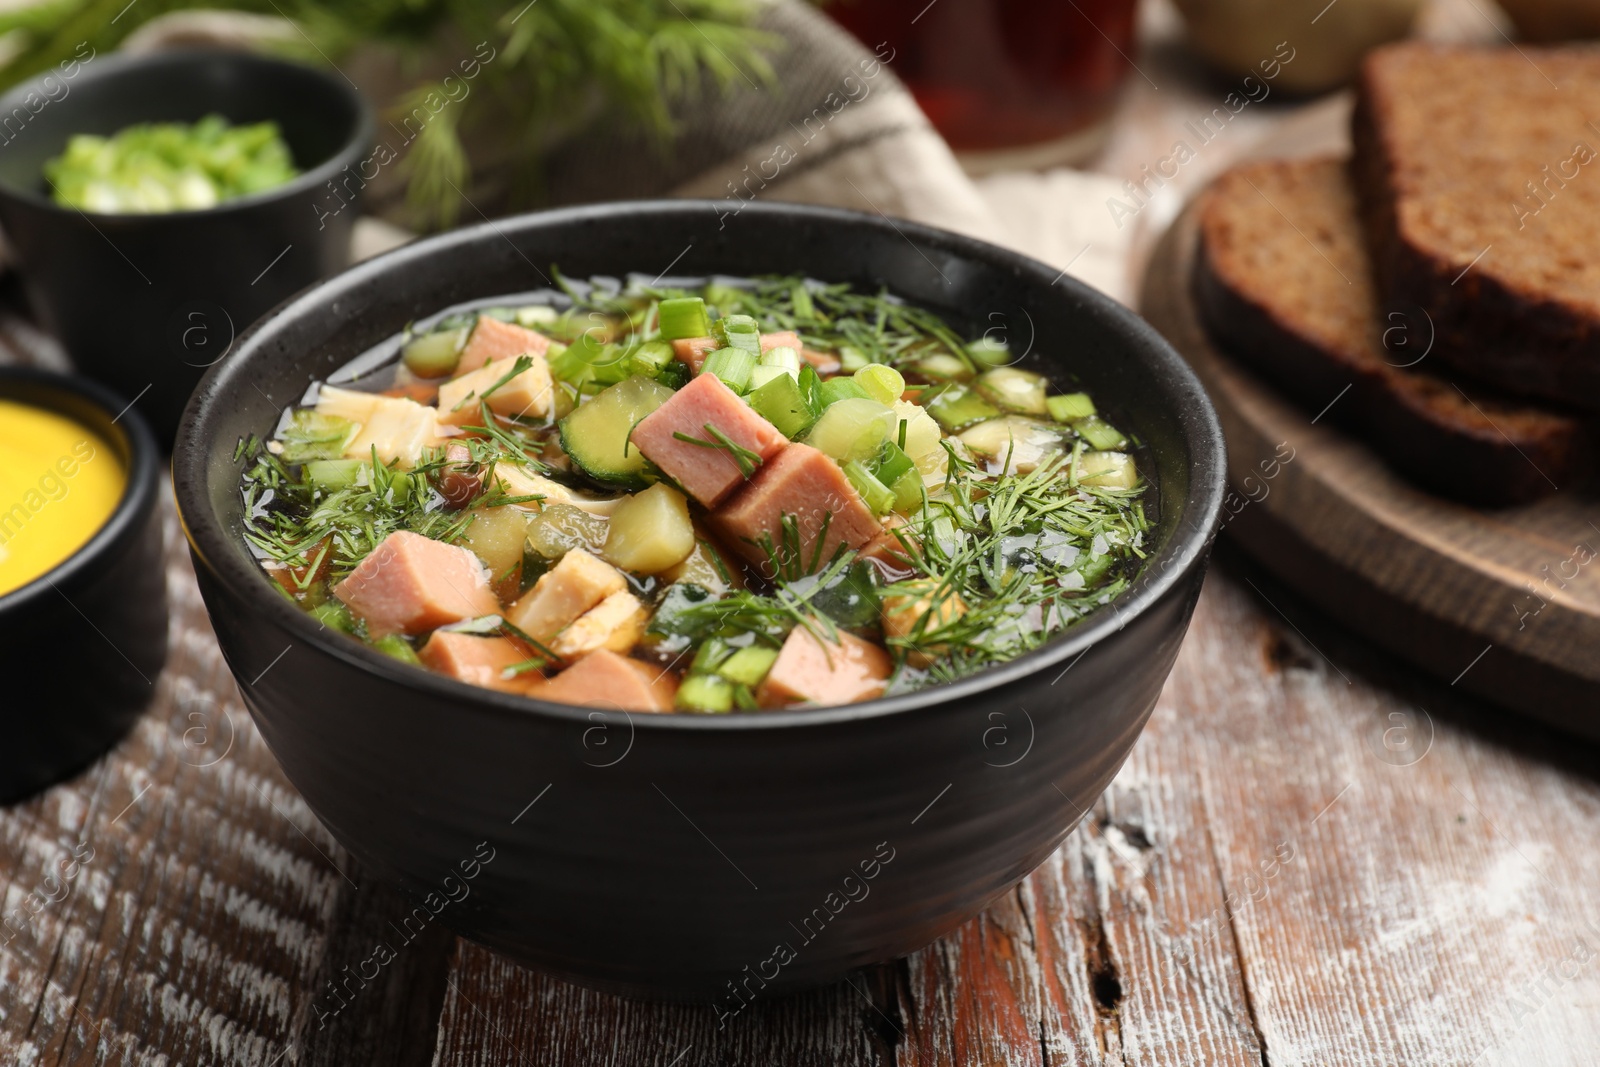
[0,0,782,227]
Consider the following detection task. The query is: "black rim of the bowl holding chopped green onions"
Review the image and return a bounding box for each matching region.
[0,48,378,226]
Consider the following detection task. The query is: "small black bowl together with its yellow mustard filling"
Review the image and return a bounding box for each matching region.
[0,368,166,803]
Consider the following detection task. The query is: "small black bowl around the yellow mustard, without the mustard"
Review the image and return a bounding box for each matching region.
[0,366,166,803]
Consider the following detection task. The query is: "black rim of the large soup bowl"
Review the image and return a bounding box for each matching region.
[173,200,1227,731]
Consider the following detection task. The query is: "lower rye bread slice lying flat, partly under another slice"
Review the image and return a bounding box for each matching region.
[1195,158,1589,506]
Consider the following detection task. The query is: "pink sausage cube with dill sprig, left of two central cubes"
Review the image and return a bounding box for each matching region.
[632,374,789,507]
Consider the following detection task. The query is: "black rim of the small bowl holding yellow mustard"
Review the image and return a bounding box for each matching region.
[0,366,160,619]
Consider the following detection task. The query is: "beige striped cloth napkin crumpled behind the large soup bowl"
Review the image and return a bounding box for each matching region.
[125,0,1131,301]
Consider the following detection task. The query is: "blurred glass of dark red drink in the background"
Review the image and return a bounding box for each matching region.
[826,0,1138,174]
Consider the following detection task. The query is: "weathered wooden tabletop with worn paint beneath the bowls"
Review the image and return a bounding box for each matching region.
[0,4,1600,1067]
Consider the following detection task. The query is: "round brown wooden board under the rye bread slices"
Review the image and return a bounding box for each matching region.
[1139,205,1600,737]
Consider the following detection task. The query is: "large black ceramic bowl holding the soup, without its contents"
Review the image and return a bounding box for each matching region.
[173,202,1224,1011]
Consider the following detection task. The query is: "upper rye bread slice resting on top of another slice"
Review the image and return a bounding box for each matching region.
[1354,43,1600,410]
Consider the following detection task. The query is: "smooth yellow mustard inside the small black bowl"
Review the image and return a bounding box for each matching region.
[0,400,126,597]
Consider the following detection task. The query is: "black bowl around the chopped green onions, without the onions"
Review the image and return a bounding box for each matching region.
[0,51,373,442]
